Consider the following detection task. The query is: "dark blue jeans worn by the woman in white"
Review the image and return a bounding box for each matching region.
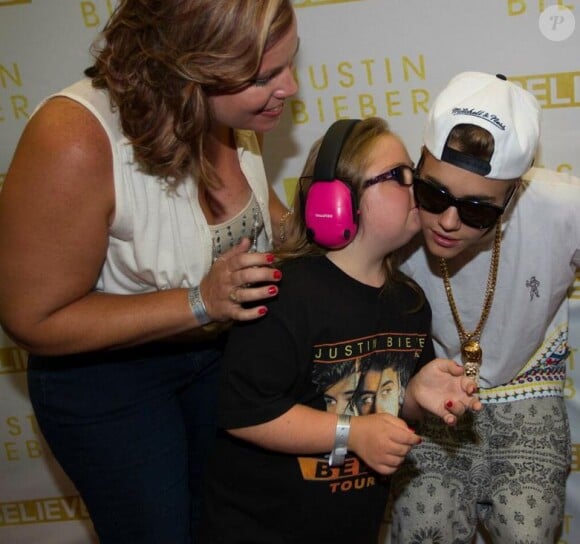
[28,344,222,544]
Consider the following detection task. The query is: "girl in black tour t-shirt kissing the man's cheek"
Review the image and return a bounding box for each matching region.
[201,118,480,544]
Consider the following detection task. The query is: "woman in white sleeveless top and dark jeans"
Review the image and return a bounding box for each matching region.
[0,0,298,544]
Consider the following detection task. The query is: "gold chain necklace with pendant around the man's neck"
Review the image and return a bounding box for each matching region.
[439,220,501,384]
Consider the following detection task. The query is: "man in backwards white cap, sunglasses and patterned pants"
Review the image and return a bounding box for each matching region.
[392,72,580,544]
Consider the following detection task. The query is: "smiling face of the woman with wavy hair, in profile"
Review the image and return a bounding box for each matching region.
[209,15,298,132]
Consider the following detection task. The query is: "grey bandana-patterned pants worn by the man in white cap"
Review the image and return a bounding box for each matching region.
[391,397,571,544]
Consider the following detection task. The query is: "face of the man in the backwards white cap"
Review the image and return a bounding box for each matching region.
[417,150,515,259]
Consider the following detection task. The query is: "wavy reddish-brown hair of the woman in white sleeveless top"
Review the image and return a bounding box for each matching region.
[85,0,294,186]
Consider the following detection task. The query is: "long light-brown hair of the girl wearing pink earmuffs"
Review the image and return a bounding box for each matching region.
[275,117,425,304]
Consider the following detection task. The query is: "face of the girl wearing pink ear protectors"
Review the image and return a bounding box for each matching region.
[357,134,420,254]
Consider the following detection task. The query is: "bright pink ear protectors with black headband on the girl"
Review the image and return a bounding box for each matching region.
[303,119,360,249]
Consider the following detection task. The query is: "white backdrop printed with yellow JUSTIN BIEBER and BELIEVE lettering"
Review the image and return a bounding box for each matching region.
[0,0,580,544]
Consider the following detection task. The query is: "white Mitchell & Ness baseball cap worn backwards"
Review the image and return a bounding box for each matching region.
[423,72,541,179]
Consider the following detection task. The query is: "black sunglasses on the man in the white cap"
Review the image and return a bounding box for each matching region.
[413,175,515,229]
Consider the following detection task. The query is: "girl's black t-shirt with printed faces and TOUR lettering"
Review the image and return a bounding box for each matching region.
[201,257,434,544]
